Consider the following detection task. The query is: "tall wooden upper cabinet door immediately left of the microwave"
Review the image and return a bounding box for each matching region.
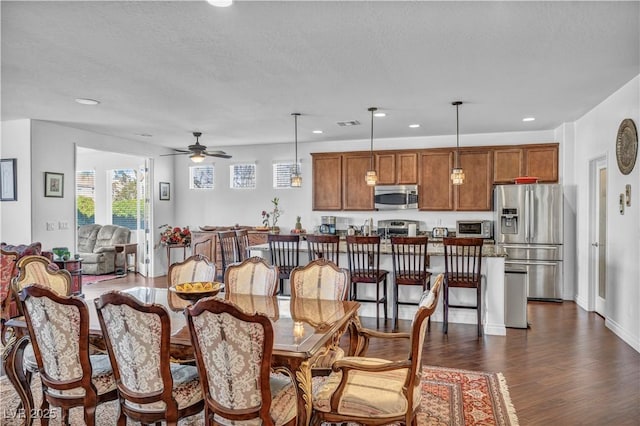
[342,152,373,210]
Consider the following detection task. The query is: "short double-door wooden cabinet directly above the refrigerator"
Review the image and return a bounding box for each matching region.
[493,144,558,184]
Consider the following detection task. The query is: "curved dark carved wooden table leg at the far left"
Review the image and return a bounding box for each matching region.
[2,336,34,426]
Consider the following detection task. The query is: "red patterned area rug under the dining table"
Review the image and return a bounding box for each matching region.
[0,367,518,426]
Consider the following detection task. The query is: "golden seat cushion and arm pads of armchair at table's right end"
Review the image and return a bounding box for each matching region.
[313,357,422,418]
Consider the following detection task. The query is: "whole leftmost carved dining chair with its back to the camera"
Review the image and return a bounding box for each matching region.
[20,284,118,426]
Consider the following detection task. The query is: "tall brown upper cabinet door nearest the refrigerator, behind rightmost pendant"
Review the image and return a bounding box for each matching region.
[454,149,493,211]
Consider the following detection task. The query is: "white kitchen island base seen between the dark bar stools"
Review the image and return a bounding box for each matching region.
[249,241,506,336]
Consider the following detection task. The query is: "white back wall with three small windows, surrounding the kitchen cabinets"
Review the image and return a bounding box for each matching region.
[172,131,562,231]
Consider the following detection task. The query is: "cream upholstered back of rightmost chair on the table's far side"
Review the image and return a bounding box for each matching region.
[291,265,349,300]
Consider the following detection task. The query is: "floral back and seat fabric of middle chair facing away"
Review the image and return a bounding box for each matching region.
[102,305,202,411]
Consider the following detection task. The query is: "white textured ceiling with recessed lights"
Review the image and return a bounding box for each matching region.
[1,1,640,148]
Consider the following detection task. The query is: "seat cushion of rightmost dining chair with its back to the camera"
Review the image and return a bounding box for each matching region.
[215,374,298,426]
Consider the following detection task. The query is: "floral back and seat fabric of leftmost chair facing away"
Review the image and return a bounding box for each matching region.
[24,297,115,397]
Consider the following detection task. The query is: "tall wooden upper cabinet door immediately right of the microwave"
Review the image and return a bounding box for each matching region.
[418,150,454,210]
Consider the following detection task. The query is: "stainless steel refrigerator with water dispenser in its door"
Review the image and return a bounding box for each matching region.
[494,184,563,301]
